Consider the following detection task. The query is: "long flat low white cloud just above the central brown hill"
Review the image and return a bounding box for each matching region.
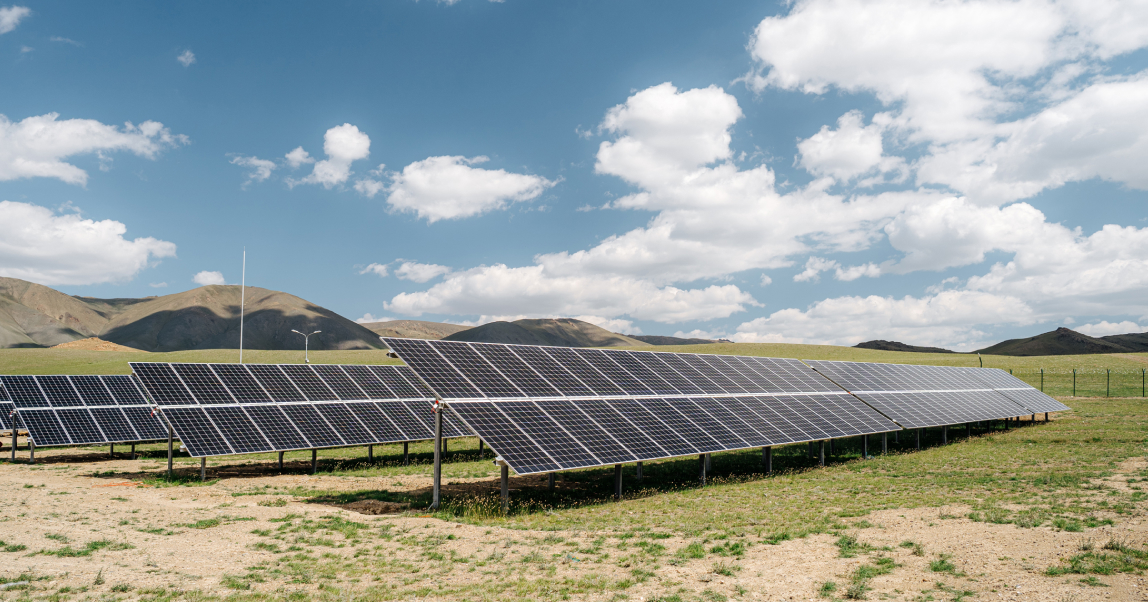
[386,265,754,322]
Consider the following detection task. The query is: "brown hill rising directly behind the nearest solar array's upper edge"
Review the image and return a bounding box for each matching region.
[442,318,646,347]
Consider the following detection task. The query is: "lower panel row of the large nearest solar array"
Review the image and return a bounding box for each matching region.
[448,394,898,474]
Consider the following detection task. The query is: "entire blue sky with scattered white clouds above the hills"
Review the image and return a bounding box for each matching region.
[0,0,1148,350]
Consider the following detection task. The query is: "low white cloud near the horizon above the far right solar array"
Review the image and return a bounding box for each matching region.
[730,291,1035,350]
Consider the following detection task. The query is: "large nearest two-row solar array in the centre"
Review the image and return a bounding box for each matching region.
[383,338,899,474]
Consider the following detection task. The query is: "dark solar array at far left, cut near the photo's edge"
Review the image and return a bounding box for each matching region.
[0,376,168,447]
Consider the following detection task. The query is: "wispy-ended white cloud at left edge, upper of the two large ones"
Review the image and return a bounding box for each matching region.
[0,113,188,185]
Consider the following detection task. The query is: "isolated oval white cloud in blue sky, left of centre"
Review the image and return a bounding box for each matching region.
[383,156,558,223]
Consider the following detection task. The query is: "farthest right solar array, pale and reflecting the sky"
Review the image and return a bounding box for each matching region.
[806,360,1069,429]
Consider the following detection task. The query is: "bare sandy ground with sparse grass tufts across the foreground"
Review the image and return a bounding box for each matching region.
[0,449,1148,602]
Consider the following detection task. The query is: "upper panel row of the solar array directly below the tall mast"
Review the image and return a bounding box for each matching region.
[131,362,434,406]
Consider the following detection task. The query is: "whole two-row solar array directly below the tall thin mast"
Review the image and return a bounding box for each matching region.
[131,362,471,457]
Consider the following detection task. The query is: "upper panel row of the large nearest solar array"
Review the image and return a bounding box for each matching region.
[383,338,839,399]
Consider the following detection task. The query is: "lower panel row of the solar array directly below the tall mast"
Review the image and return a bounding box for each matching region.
[161,400,468,457]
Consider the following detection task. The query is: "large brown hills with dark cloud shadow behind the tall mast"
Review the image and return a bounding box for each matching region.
[0,278,381,352]
